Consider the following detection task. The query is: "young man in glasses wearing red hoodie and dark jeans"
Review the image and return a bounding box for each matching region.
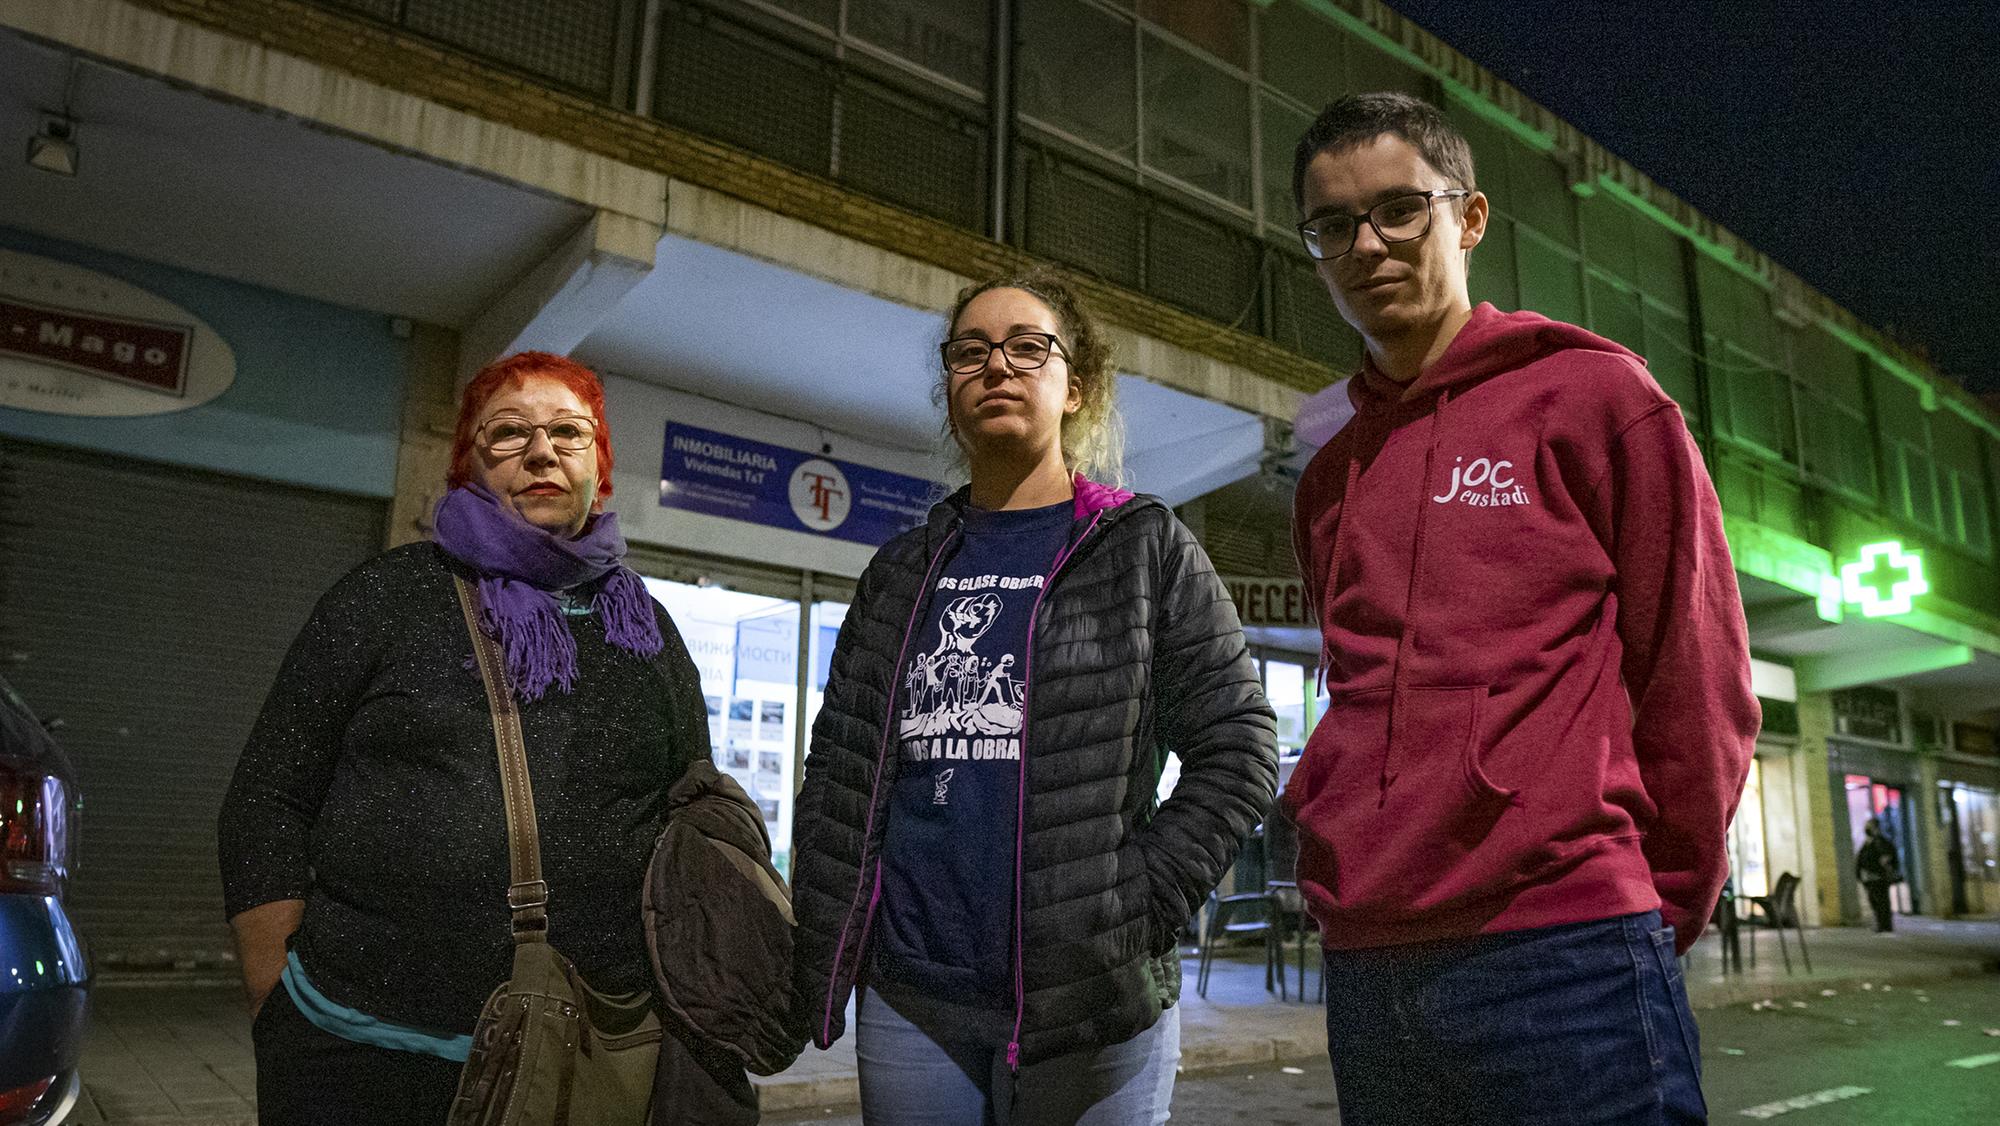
[1284,94,1760,1126]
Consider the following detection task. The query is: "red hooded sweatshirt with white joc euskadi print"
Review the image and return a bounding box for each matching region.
[1282,304,1760,950]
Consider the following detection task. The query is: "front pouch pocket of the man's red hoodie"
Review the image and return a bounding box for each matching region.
[1286,686,1524,920]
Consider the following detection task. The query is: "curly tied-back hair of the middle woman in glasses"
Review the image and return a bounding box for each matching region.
[930,268,1124,486]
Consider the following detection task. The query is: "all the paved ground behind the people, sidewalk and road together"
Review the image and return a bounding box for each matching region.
[62,918,2000,1126]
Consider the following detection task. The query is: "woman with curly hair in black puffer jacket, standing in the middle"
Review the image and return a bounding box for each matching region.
[792,274,1276,1126]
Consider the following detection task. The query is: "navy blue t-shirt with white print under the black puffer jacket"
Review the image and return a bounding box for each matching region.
[876,502,1072,1006]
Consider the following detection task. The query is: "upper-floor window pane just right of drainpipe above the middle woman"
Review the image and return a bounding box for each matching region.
[1020,0,1138,160]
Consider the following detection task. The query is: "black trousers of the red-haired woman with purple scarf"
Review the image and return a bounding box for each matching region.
[250,984,462,1126]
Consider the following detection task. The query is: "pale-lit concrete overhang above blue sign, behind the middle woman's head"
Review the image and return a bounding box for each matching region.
[576,182,1300,504]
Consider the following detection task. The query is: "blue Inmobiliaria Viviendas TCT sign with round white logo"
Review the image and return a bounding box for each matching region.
[660,422,942,546]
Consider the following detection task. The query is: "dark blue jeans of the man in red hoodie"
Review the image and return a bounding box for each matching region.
[1326,912,1708,1126]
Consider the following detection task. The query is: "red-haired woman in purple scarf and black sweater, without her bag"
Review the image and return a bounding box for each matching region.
[220,352,740,1126]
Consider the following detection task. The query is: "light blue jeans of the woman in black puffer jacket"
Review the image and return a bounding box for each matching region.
[854,990,1180,1126]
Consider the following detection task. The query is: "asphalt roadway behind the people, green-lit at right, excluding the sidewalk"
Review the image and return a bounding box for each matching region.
[766,974,2000,1126]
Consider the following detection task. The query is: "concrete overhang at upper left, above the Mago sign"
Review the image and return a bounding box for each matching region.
[0,0,666,366]
